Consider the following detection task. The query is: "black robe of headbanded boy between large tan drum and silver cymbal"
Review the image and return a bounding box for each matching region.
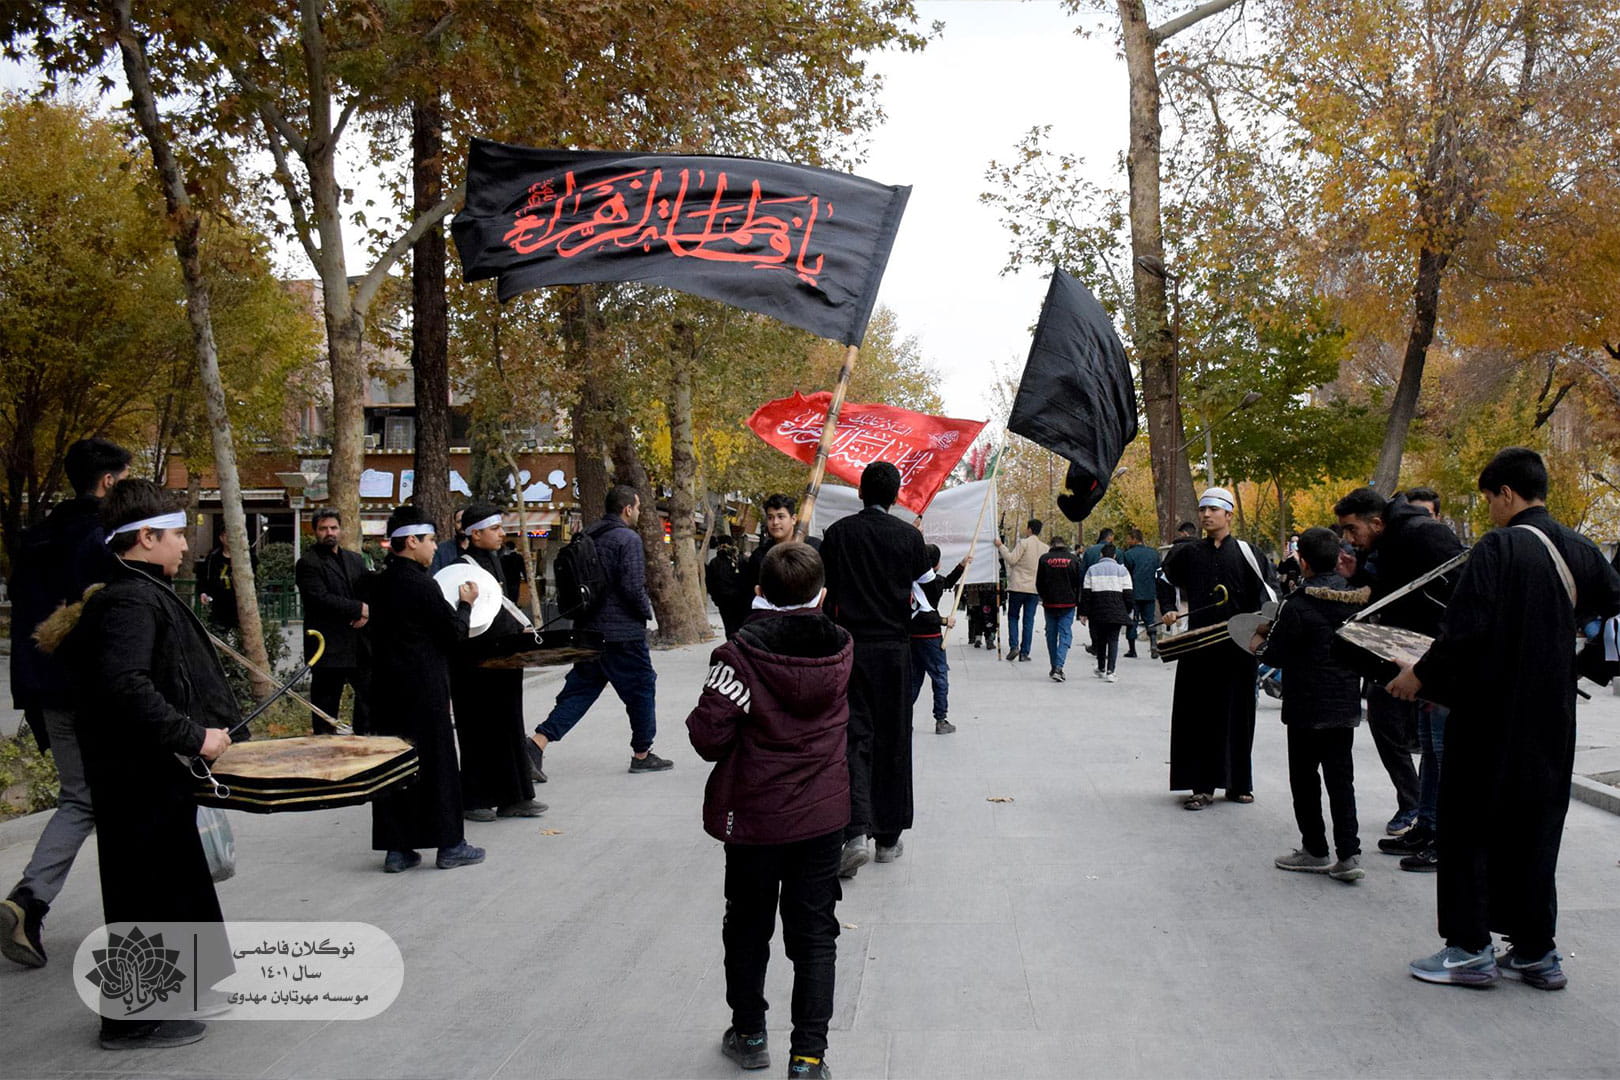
[366,555,473,852]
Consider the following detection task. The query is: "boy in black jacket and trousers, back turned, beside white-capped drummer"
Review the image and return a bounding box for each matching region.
[1252,528,1369,881]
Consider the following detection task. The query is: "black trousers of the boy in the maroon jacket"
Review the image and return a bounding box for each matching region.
[721,831,844,1057]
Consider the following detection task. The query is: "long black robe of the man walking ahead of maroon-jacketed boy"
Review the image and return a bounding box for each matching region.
[821,507,932,837]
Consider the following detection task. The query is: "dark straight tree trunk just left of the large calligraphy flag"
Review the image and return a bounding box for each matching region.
[410,94,453,539]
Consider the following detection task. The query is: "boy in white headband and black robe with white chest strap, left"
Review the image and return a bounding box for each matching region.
[450,502,546,821]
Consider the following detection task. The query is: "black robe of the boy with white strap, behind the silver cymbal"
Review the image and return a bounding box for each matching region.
[450,547,535,810]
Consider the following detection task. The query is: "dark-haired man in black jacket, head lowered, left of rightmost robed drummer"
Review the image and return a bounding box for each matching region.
[1333,487,1463,854]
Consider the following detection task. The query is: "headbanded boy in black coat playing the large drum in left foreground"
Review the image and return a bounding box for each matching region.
[45,479,240,1049]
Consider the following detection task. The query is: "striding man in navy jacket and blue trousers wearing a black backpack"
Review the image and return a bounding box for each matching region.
[523,484,676,780]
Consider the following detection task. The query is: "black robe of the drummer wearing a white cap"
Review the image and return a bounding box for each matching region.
[1160,536,1277,795]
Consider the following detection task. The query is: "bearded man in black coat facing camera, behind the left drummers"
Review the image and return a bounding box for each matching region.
[293,508,373,735]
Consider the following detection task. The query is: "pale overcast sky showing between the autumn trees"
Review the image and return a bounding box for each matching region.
[0,0,1128,419]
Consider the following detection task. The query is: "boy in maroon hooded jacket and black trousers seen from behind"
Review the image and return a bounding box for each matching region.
[687,542,854,1077]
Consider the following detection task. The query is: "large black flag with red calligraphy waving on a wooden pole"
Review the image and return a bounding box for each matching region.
[450,139,910,345]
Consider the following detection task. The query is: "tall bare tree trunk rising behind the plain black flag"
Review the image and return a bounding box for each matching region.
[1118,0,1196,536]
